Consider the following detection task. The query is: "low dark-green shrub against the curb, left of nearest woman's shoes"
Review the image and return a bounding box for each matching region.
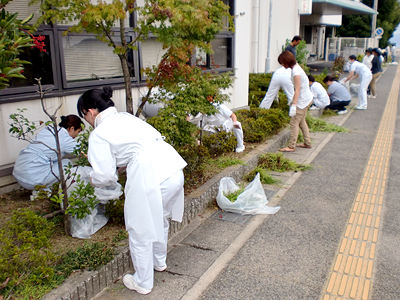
[56,243,114,277]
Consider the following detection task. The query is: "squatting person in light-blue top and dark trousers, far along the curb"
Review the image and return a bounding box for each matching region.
[324,76,351,115]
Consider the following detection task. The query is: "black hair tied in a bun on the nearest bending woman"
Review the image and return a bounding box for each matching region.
[77,87,114,118]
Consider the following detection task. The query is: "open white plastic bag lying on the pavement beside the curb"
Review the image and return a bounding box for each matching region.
[217,173,281,215]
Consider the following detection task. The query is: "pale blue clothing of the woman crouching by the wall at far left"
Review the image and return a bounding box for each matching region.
[13,127,77,190]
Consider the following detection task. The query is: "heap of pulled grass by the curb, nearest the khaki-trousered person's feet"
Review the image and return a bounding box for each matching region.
[258,153,312,172]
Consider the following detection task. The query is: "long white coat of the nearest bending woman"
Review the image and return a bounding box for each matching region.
[88,107,186,242]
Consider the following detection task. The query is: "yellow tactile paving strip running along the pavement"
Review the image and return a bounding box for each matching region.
[320,68,400,300]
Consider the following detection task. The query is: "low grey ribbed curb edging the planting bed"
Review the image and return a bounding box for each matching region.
[41,127,290,300]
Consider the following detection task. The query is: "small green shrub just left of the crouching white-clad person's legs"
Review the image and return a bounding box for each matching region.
[202,129,237,157]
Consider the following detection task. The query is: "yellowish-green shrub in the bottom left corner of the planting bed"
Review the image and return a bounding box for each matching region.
[0,209,56,296]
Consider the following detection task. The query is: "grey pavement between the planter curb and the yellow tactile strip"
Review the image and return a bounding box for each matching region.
[42,63,400,300]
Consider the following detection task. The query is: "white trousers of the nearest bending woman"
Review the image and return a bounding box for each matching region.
[128,171,184,290]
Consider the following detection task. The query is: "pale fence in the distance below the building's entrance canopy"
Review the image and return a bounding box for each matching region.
[325,37,379,61]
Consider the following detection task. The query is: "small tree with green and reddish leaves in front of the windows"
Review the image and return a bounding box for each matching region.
[33,0,232,115]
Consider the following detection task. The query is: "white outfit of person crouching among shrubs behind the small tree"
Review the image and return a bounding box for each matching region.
[203,103,243,148]
